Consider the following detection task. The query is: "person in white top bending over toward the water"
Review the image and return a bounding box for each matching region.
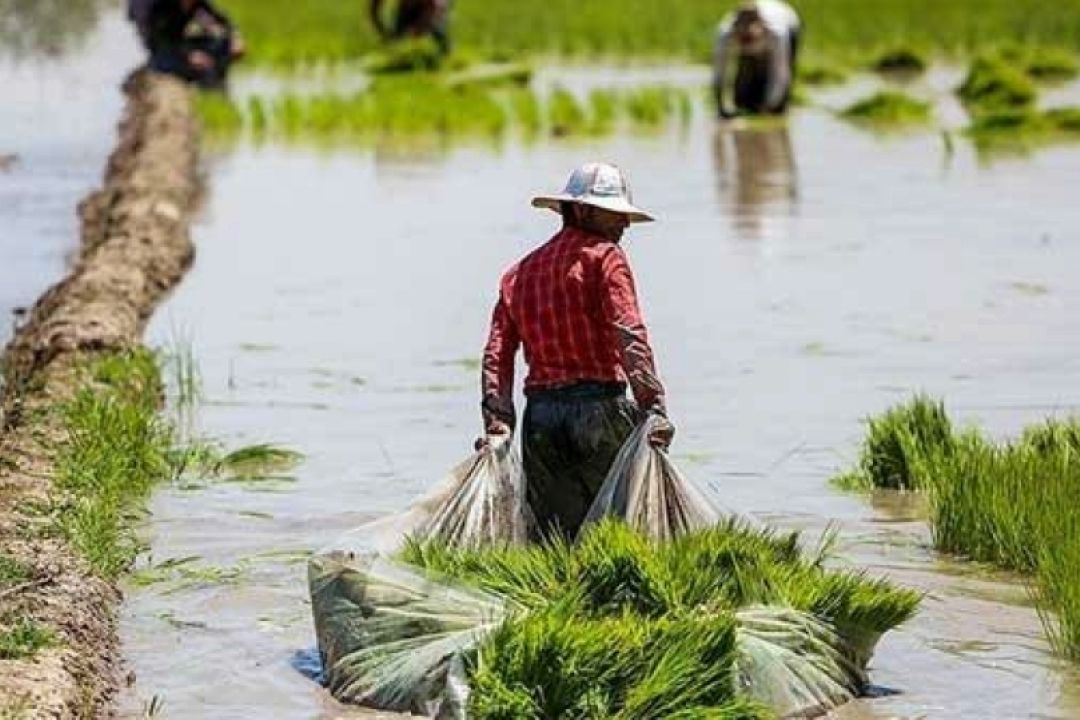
[713,0,802,118]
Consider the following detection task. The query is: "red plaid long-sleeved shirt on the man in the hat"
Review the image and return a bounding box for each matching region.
[482,228,664,424]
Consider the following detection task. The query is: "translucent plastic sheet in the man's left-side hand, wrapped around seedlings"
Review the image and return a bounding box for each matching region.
[308,437,530,720]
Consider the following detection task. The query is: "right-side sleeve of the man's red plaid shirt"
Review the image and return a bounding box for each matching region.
[600,246,666,413]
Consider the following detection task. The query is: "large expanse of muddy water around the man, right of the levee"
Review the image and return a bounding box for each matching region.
[122,66,1080,720]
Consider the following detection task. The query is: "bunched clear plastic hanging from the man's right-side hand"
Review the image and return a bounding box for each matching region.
[582,416,724,540]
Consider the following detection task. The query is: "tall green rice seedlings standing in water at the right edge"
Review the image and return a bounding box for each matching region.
[845,397,1080,661]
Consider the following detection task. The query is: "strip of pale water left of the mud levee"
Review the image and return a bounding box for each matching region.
[0,10,138,342]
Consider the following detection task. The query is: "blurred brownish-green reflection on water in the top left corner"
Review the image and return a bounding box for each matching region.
[0,0,112,57]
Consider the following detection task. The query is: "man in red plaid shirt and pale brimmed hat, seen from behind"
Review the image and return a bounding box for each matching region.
[481,163,675,538]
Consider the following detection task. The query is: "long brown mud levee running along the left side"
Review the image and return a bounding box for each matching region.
[0,74,198,718]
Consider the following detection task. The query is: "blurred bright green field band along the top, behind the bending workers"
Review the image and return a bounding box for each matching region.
[221,0,1080,67]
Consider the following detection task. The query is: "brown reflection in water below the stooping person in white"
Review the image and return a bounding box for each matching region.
[713,125,798,240]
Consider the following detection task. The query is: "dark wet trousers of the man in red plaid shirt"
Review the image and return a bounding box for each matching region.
[522,382,640,539]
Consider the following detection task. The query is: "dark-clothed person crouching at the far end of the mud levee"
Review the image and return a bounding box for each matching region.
[127,0,244,89]
